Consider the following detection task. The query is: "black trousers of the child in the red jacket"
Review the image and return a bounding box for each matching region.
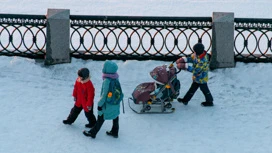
[67,105,96,125]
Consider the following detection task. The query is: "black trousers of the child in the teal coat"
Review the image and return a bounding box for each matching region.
[90,115,119,135]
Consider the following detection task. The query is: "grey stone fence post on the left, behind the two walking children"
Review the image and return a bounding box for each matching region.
[44,9,71,65]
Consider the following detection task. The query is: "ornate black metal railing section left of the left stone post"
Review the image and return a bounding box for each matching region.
[0,14,46,58]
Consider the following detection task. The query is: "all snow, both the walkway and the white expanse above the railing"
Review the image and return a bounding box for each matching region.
[0,0,272,153]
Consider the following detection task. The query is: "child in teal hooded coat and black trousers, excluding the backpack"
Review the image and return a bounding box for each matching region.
[83,61,120,138]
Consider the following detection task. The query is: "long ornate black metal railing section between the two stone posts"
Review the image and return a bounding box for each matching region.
[70,15,212,60]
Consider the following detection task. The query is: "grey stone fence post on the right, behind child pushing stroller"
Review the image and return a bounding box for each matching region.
[210,12,235,69]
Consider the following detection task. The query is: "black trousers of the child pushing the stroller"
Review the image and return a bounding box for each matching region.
[183,82,213,102]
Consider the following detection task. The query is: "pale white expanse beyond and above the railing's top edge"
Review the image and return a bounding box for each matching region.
[1,0,272,18]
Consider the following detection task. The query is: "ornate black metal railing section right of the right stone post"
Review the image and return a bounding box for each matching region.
[234,18,272,62]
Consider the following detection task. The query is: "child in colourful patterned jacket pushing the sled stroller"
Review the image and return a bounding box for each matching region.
[176,43,214,107]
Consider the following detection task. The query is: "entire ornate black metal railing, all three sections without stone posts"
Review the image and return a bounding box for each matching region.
[0,14,272,62]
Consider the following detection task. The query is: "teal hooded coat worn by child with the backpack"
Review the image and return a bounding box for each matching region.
[98,61,120,120]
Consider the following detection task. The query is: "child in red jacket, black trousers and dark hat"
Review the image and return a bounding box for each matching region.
[63,68,96,128]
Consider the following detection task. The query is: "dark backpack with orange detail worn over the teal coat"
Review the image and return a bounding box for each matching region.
[106,79,124,105]
